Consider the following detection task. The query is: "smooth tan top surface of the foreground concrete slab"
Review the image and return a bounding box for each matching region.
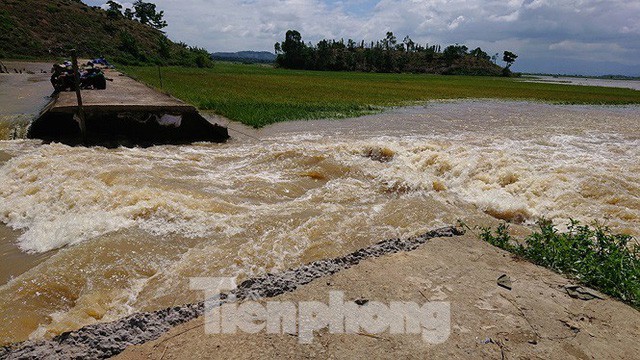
[118,233,640,360]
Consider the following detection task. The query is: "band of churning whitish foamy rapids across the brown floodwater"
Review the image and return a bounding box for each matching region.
[0,128,640,252]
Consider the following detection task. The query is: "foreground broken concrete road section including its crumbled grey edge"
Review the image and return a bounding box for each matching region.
[0,228,640,359]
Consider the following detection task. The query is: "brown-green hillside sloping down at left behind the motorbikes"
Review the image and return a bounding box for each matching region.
[0,0,211,66]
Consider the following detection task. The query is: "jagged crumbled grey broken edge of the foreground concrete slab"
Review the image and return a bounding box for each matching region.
[0,226,464,359]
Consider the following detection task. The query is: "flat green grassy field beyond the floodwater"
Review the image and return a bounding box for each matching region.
[122,63,640,127]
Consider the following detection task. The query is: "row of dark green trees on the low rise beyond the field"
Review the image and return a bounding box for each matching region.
[275,30,518,76]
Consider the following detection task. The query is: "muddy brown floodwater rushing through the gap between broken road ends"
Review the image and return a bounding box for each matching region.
[0,101,640,343]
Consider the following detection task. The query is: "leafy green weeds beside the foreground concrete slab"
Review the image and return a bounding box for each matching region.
[480,220,640,309]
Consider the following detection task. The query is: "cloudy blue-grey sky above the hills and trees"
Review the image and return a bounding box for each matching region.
[85,0,640,75]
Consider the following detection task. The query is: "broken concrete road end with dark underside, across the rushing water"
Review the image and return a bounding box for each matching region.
[27,70,229,147]
